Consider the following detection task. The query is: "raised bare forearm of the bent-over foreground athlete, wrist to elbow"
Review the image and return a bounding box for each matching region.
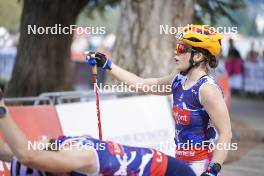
[0,114,31,161]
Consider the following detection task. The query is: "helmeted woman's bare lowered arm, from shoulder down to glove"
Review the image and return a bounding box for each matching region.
[200,84,232,164]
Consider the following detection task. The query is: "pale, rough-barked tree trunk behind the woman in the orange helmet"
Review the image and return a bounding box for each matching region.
[113,0,194,77]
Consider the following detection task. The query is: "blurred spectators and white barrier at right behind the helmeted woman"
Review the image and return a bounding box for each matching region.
[221,38,264,93]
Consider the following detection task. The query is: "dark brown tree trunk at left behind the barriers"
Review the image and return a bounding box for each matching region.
[7,0,88,96]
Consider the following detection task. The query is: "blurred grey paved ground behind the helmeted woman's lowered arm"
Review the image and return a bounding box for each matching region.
[222,97,264,176]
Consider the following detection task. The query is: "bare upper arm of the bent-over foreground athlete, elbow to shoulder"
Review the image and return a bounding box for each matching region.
[21,148,97,173]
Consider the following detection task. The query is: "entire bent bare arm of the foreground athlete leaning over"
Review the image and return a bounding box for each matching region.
[0,101,97,173]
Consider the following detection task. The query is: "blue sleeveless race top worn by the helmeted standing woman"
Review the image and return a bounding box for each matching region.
[172,74,221,147]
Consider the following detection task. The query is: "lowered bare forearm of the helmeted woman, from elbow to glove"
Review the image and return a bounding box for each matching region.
[212,134,231,165]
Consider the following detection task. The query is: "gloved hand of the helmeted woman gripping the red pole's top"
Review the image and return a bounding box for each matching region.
[85,51,112,70]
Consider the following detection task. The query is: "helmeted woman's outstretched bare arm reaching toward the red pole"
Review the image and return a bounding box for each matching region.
[109,64,175,95]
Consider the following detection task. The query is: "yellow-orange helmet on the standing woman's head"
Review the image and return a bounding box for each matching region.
[176,24,223,56]
